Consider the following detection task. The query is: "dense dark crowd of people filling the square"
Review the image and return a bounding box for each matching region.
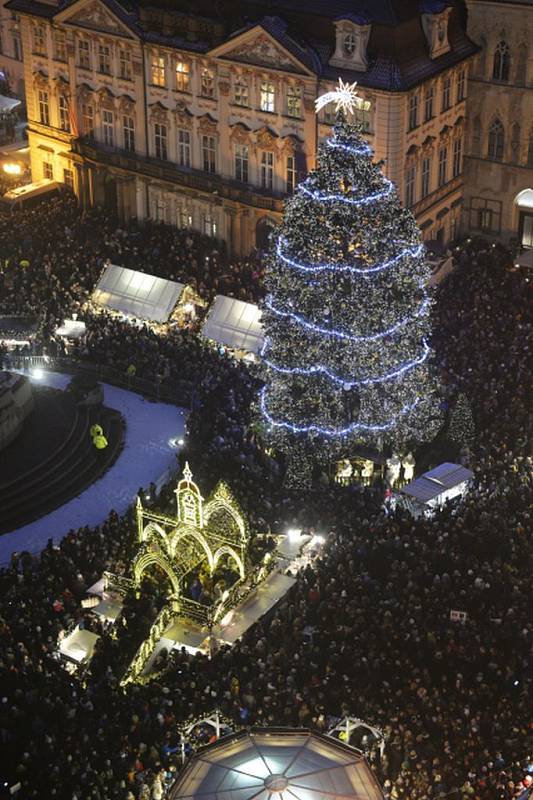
[0,200,533,800]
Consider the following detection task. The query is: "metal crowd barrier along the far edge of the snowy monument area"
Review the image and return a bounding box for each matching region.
[4,353,194,408]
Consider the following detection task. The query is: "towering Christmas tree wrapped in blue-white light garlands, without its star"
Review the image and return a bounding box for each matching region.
[260,89,440,476]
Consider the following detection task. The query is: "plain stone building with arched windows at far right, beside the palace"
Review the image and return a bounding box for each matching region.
[463,0,533,247]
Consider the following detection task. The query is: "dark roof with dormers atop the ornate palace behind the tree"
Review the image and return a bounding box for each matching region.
[6,0,479,92]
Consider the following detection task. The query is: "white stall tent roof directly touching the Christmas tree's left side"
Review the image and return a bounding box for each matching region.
[202,294,264,353]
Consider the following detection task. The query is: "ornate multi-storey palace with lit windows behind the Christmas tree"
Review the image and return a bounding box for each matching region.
[6,0,477,254]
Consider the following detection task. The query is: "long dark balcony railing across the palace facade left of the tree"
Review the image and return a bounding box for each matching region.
[72,137,284,213]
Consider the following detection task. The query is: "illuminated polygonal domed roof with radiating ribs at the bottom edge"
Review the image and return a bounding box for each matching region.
[170,728,383,800]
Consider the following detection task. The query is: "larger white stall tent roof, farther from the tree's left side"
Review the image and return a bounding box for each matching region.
[92,264,185,322]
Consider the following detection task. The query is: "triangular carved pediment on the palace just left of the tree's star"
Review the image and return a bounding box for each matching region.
[210,26,309,75]
